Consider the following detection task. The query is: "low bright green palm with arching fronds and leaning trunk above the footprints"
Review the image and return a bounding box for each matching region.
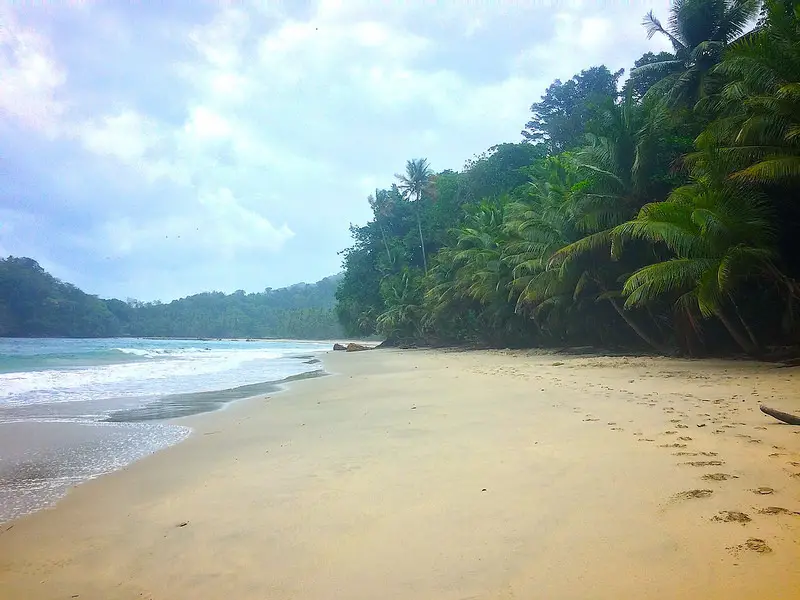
[613,176,780,354]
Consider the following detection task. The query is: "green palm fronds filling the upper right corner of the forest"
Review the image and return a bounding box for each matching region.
[690,0,800,183]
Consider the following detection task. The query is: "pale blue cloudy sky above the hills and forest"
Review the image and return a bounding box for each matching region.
[0,0,669,300]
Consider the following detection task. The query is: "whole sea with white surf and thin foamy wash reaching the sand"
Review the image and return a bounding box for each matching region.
[0,338,331,522]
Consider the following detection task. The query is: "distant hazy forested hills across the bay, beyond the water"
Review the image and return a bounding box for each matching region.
[0,256,342,339]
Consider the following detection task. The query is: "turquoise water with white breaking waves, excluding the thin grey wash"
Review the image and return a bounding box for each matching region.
[0,338,330,422]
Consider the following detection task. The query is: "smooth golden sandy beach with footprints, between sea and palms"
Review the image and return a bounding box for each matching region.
[0,351,800,600]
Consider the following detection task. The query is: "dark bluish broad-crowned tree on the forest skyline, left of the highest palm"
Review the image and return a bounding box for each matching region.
[522,65,624,154]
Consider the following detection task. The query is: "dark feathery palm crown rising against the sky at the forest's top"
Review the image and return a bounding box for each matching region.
[634,0,760,107]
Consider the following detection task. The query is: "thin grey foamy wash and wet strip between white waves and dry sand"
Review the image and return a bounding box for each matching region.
[0,355,328,531]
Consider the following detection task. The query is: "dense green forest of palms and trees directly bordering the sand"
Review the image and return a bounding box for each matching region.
[337,0,800,356]
